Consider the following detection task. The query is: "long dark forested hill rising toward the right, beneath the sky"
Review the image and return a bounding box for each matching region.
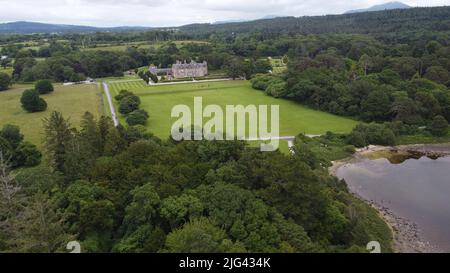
[177,6,450,35]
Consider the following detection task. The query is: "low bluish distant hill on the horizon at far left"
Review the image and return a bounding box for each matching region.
[0,21,148,34]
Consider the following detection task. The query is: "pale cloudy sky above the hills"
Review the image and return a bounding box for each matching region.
[0,0,450,27]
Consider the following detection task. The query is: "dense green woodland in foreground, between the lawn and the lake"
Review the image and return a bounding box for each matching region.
[0,112,391,253]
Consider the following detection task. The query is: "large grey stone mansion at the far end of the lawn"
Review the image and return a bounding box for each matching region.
[149,61,208,79]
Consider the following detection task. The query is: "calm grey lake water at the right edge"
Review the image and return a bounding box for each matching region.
[337,157,450,252]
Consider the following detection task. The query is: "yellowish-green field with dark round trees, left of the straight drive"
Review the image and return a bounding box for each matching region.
[0,85,104,146]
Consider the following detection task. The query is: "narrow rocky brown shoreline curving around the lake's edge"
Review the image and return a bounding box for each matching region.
[329,143,450,253]
